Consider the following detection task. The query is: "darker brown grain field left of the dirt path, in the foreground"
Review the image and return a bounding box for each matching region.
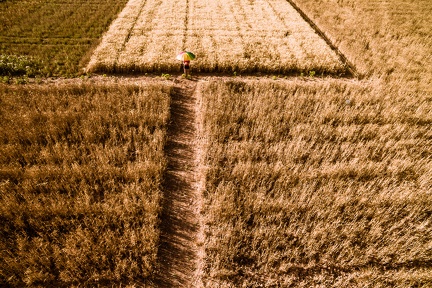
[0,84,171,287]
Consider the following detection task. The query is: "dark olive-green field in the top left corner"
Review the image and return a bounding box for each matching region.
[0,0,127,77]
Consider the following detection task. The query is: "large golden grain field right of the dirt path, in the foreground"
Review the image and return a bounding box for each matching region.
[202,80,432,287]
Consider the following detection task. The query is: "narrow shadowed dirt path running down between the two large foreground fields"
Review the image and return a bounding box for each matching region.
[155,79,204,288]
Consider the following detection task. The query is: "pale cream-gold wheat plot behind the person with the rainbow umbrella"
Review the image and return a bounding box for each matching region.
[88,0,346,74]
